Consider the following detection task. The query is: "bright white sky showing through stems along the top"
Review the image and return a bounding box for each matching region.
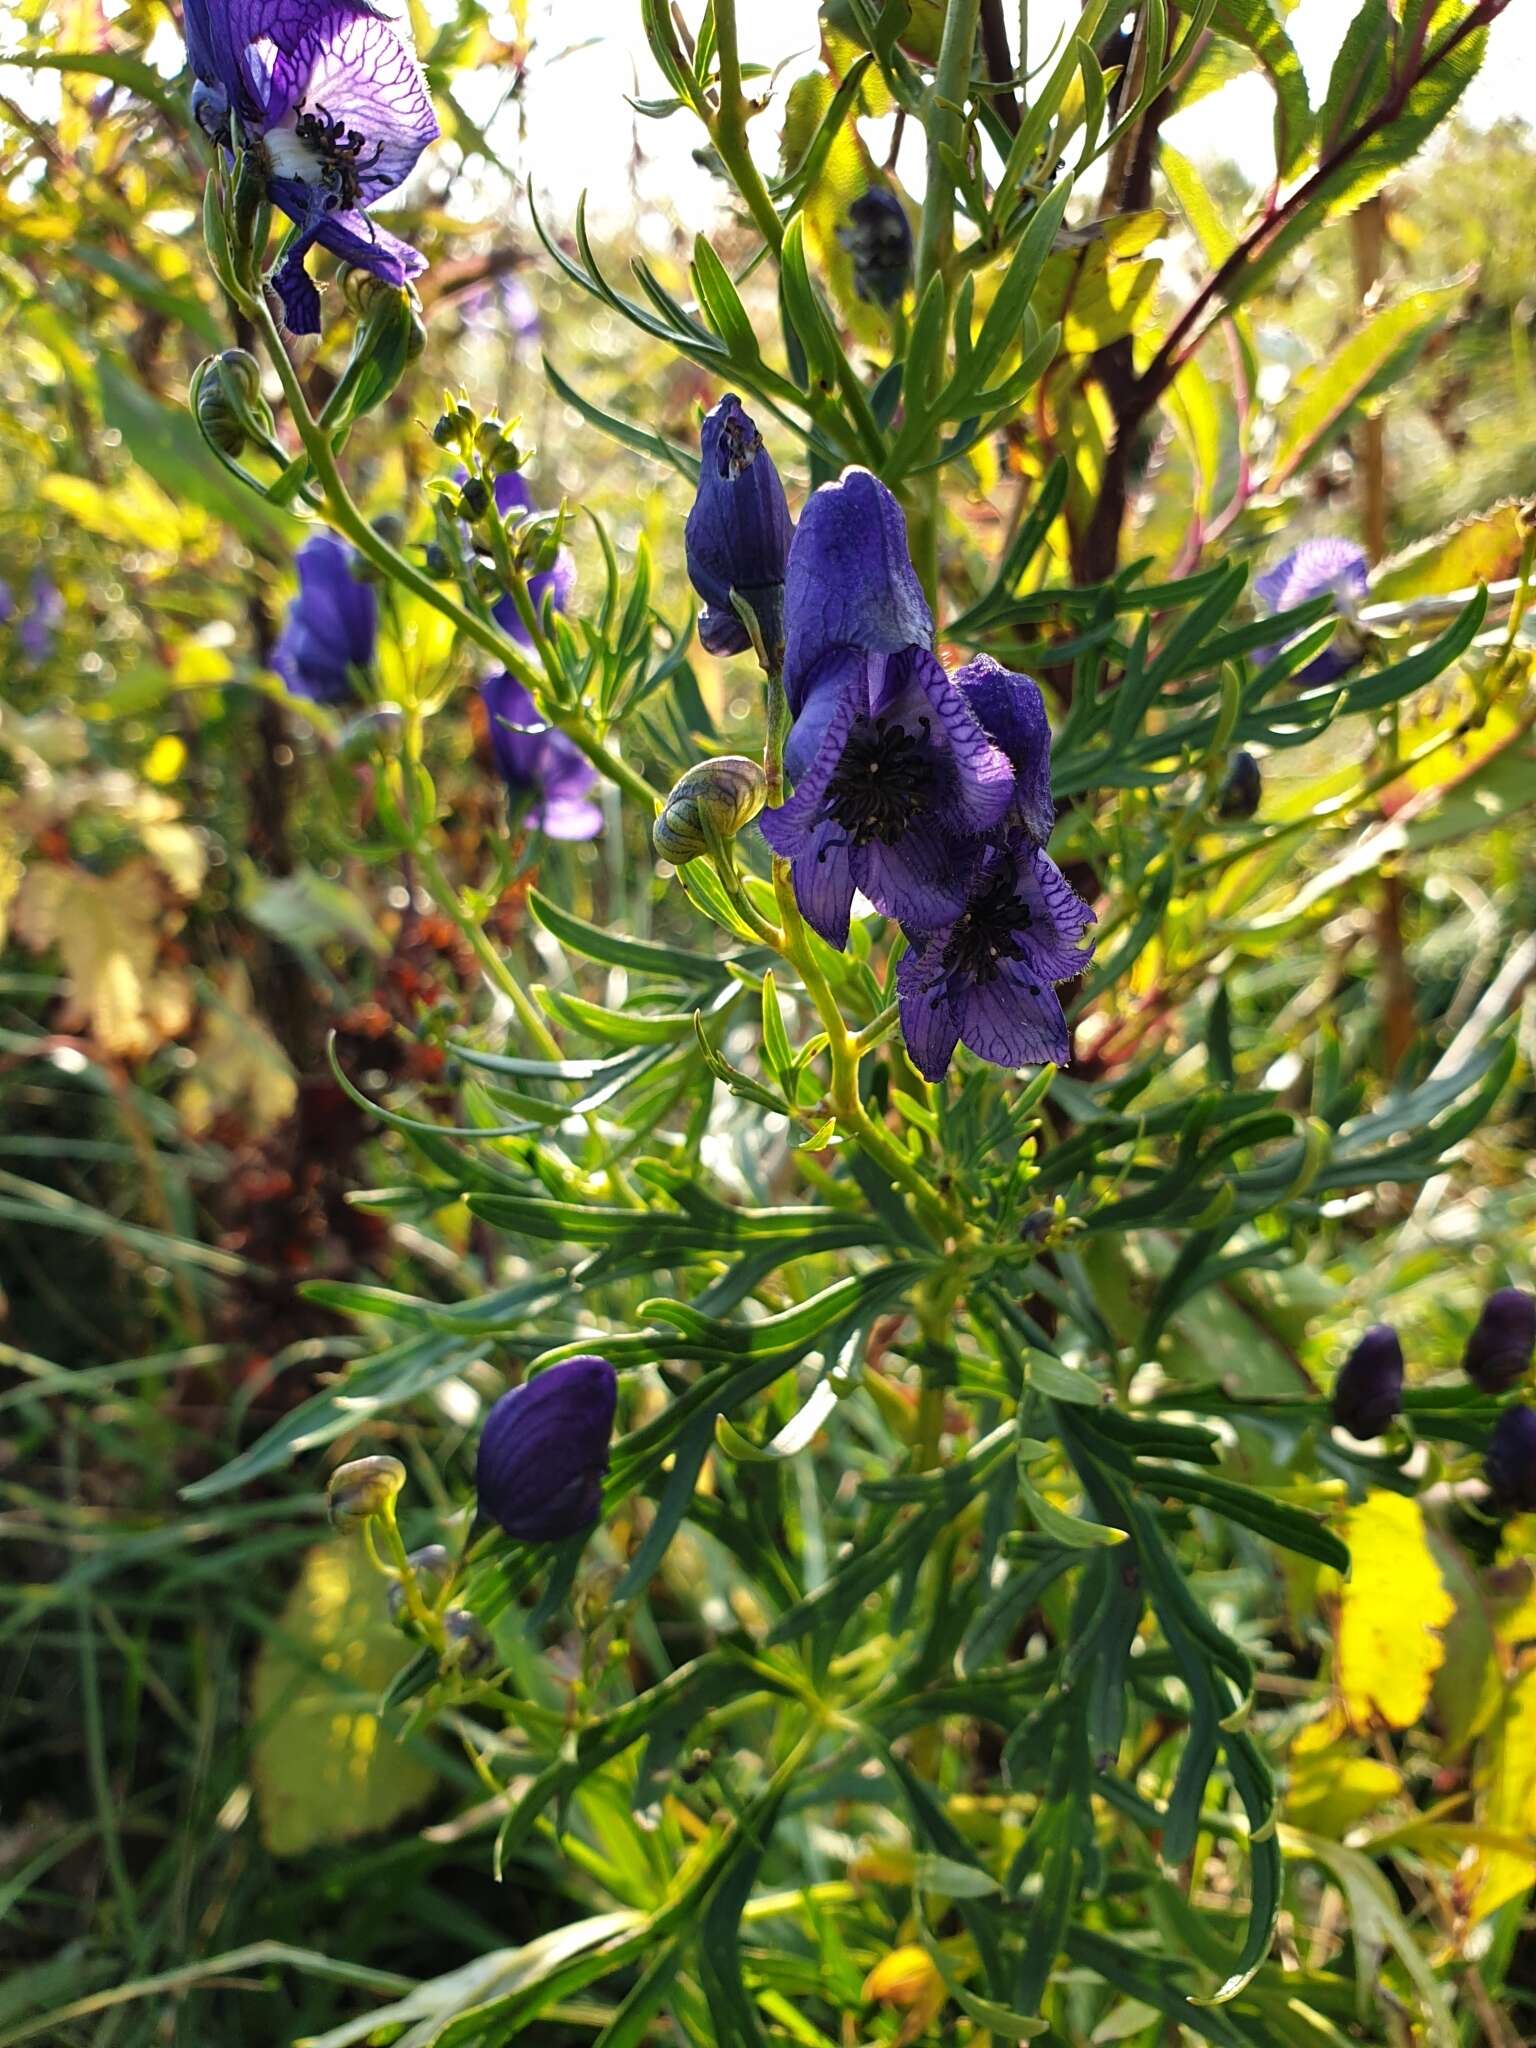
[518,0,1536,225]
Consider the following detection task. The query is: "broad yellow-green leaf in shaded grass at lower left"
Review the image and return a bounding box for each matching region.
[250,1542,434,1855]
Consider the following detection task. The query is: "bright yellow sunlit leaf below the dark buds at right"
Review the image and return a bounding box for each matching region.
[1335,1493,1454,1729]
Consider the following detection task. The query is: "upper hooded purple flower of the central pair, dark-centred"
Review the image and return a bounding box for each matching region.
[760,469,1024,946]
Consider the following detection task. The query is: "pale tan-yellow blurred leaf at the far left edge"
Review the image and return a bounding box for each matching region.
[14,860,193,1057]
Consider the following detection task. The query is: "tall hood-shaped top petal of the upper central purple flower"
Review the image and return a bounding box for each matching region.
[784,469,934,713]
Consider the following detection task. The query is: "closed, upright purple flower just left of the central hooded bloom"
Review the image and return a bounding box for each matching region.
[682,393,793,666]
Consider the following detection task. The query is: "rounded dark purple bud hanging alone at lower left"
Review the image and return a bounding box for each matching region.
[475,1358,618,1542]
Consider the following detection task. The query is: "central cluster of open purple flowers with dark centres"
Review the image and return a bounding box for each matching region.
[760,469,1094,1081]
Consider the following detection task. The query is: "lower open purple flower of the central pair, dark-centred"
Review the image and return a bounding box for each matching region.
[897,834,1094,1081]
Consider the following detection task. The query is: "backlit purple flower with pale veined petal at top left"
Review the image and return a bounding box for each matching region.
[186,0,438,334]
